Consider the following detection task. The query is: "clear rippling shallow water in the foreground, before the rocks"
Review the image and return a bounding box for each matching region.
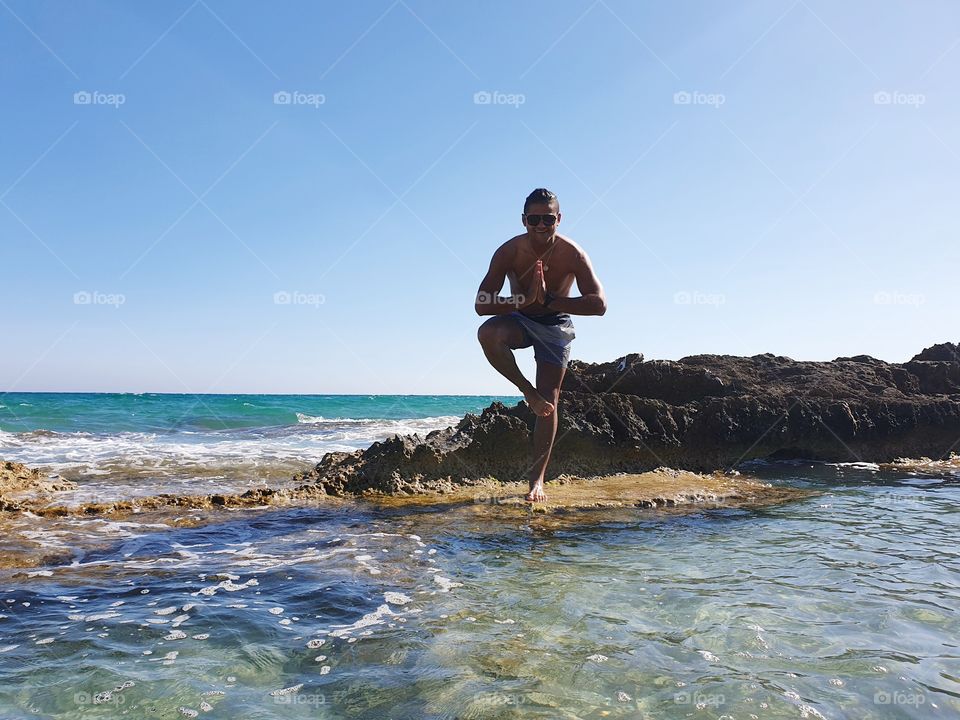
[0,396,960,719]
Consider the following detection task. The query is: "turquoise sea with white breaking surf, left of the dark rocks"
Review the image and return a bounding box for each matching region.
[0,393,519,501]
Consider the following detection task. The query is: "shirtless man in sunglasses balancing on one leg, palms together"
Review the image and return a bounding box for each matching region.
[474,188,607,502]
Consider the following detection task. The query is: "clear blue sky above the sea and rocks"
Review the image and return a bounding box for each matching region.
[0,0,960,394]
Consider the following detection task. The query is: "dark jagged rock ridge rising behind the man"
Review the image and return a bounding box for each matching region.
[297,343,960,495]
